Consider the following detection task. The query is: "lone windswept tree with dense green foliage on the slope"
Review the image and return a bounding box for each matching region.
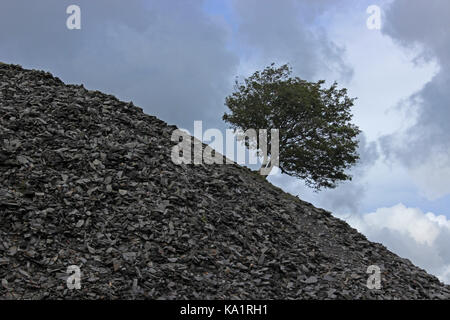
[223,63,360,190]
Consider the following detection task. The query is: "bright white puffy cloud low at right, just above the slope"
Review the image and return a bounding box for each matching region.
[337,203,450,284]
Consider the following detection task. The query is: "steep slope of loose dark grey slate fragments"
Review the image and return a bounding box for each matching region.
[0,64,450,299]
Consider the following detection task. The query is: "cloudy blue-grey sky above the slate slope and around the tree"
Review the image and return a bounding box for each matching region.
[0,0,450,283]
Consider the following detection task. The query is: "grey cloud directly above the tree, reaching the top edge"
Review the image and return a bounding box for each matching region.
[233,0,353,80]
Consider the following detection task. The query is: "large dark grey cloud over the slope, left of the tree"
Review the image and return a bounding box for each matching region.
[0,0,239,132]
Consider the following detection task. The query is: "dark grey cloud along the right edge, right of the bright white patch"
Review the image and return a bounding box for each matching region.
[380,0,450,166]
